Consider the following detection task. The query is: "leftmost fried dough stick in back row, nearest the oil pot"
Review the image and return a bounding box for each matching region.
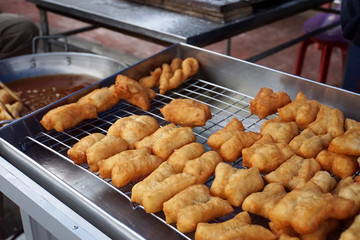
[40,103,97,132]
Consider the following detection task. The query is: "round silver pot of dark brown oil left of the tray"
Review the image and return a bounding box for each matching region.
[0,52,127,121]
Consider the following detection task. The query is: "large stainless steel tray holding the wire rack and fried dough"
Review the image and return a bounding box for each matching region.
[0,44,360,239]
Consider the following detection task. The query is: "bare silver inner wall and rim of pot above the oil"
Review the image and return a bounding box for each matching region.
[0,52,127,83]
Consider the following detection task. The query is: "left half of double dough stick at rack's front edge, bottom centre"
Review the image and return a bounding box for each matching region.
[163,184,210,224]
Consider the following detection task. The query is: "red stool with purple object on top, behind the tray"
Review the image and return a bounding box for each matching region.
[294,13,348,83]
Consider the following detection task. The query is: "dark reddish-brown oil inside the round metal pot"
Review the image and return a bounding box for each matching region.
[6,74,100,114]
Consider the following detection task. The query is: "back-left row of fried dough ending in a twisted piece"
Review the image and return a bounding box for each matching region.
[40,57,199,132]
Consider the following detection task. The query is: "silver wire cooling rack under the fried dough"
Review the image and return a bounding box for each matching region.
[24,78,266,239]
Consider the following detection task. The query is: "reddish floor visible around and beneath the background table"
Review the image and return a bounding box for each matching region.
[0,0,342,86]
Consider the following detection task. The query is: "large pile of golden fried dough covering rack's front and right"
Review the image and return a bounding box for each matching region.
[64,85,360,240]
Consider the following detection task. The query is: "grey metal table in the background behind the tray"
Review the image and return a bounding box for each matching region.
[27,0,332,50]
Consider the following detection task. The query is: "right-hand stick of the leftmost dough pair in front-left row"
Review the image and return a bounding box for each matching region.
[86,135,128,172]
